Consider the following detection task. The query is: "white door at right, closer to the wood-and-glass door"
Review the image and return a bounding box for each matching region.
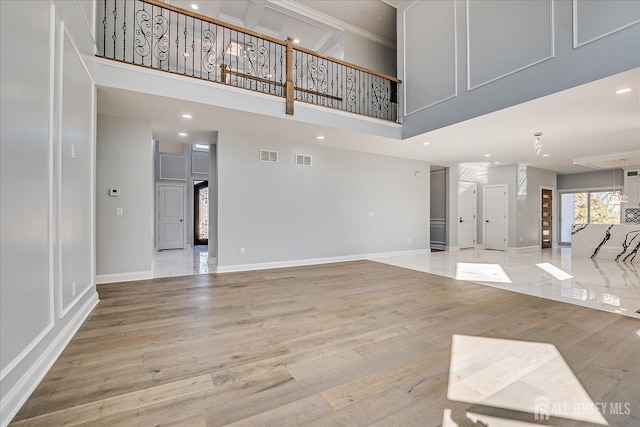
[484,185,508,251]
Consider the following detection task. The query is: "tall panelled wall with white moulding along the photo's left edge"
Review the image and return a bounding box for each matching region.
[0,1,98,425]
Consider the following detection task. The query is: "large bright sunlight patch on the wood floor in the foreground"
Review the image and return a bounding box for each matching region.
[447,335,609,427]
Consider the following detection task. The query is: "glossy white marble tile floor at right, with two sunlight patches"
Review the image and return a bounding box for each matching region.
[372,247,640,319]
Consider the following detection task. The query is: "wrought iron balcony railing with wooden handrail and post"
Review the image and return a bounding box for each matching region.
[97,0,401,121]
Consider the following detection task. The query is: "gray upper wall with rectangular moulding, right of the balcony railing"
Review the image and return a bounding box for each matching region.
[398,0,640,137]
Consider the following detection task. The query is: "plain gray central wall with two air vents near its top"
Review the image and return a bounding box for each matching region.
[217,132,430,267]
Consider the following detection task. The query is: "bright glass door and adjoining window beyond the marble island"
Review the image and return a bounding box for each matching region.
[560,191,620,243]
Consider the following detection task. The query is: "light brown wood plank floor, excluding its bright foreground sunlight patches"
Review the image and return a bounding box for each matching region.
[13,261,640,426]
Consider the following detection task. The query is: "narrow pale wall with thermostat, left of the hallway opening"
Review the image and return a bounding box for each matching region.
[96,115,154,283]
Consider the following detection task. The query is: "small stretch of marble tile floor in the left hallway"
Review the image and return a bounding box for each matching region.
[153,246,215,279]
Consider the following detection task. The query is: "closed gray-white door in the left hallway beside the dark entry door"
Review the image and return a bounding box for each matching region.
[157,184,184,249]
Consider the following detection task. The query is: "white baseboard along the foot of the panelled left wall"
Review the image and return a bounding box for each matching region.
[0,292,100,426]
